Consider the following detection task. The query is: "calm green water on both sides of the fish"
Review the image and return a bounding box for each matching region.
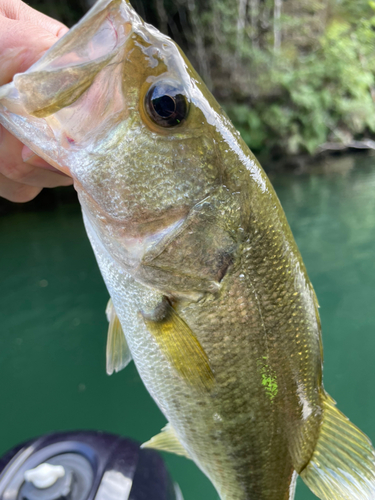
[0,156,375,500]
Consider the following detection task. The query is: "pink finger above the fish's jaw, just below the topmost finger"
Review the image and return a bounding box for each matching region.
[0,16,61,85]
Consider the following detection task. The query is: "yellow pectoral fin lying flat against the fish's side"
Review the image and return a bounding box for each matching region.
[143,302,214,390]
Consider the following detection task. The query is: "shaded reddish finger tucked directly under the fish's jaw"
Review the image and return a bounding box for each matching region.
[0,128,73,188]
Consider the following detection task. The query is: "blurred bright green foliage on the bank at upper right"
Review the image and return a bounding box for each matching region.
[226,2,375,154]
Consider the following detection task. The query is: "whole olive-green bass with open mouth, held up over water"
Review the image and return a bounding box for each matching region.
[0,0,375,500]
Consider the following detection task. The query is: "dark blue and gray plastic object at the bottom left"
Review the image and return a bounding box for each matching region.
[0,431,183,500]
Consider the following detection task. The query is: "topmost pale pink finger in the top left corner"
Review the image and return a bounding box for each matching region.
[1,0,68,37]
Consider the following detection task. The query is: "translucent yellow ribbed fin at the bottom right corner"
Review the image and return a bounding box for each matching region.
[300,396,375,500]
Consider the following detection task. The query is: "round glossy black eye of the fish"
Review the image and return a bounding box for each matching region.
[146,82,189,127]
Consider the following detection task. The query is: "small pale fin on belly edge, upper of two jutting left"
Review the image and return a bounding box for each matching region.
[105,299,132,375]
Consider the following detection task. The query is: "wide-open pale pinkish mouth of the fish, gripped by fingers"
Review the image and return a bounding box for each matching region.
[0,0,144,178]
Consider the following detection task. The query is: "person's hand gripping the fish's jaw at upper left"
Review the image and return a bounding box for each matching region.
[0,0,73,203]
